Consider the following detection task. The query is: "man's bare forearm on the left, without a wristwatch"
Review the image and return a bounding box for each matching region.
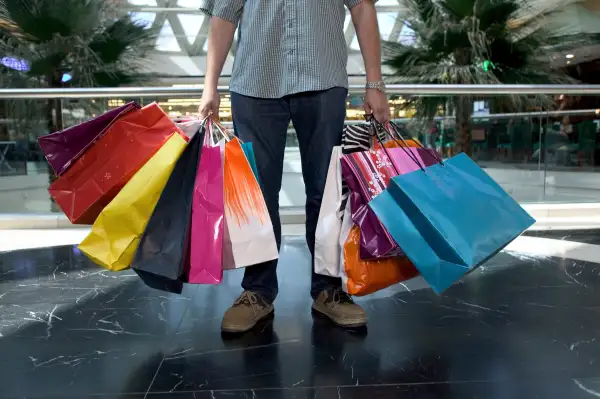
[204,17,236,88]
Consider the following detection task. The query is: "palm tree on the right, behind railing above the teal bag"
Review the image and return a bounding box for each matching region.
[384,0,586,154]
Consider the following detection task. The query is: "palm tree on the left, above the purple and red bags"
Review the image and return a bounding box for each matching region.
[0,0,155,139]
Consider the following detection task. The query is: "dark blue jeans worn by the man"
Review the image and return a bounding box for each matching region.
[231,87,348,302]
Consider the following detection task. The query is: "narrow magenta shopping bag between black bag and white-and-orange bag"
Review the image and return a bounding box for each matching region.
[188,119,225,284]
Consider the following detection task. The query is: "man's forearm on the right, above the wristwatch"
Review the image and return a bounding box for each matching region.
[350,0,381,82]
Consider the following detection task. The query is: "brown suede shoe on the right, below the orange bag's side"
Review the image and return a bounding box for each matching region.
[313,288,367,328]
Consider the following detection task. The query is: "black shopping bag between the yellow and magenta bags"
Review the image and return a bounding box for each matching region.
[131,126,205,287]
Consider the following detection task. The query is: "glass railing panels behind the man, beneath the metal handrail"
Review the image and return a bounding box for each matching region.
[0,85,600,214]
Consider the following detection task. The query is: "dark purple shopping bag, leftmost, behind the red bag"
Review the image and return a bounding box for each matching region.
[38,102,140,176]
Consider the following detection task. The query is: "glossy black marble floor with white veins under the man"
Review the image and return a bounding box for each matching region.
[0,238,600,399]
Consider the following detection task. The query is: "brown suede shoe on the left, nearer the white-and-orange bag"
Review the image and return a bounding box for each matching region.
[221,291,274,333]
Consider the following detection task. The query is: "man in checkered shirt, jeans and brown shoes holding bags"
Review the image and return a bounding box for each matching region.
[199,0,389,332]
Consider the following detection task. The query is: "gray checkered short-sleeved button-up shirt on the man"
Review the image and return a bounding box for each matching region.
[200,0,372,98]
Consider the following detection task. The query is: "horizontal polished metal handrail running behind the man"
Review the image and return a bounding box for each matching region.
[0,84,600,100]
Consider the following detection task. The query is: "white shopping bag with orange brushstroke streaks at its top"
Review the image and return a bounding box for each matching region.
[221,138,279,269]
